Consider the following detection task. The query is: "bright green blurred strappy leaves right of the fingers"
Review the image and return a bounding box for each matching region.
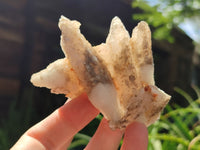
[148,87,200,150]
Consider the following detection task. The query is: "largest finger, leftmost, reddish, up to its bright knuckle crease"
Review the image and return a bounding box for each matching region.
[11,94,99,150]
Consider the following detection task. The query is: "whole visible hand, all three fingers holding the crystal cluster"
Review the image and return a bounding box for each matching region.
[11,94,148,150]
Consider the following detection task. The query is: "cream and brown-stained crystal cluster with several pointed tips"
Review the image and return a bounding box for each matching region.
[31,16,170,129]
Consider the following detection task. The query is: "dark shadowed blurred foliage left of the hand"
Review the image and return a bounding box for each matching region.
[0,89,38,150]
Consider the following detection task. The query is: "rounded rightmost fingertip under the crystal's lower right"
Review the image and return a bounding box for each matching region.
[121,122,148,150]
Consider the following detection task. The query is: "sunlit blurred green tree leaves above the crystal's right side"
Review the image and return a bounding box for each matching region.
[132,0,200,43]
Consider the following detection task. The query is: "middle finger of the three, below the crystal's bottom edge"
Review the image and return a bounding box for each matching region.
[85,119,123,150]
